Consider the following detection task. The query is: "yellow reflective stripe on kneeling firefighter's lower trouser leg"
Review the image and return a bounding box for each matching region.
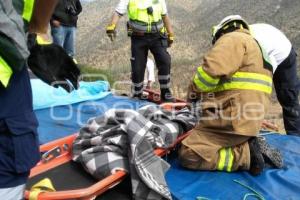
[217,148,234,172]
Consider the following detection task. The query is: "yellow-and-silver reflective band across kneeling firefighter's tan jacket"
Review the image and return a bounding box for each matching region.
[194,67,272,94]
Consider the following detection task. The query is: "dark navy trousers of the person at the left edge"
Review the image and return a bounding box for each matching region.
[0,67,40,188]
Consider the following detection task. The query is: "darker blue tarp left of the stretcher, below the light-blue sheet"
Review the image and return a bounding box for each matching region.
[35,94,149,144]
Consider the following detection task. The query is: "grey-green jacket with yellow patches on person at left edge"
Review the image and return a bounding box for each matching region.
[0,0,34,87]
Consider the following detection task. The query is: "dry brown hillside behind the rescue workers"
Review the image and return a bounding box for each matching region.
[77,0,300,93]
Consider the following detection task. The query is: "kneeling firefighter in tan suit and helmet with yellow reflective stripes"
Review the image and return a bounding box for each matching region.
[179,15,282,175]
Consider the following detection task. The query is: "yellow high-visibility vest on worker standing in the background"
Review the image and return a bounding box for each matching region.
[128,0,163,32]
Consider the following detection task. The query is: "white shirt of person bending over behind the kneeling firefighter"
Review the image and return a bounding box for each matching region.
[250,24,292,72]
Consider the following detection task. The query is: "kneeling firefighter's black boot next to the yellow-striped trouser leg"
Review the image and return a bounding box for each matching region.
[248,137,265,176]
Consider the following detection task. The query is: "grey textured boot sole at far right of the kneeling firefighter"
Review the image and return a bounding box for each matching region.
[258,138,283,169]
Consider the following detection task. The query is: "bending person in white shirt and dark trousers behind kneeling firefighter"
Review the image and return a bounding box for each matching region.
[250,24,300,136]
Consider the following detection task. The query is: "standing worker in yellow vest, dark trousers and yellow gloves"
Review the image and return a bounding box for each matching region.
[106,0,174,101]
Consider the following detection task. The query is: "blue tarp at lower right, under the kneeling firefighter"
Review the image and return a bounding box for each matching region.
[166,134,300,200]
